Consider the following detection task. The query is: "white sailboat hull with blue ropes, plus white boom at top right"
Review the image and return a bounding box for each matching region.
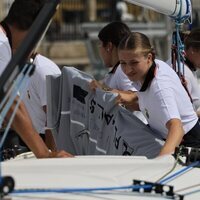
[1,0,200,200]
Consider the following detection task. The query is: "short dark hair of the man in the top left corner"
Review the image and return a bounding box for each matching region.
[4,0,46,30]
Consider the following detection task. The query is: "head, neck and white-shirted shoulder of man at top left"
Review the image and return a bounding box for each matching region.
[0,0,45,74]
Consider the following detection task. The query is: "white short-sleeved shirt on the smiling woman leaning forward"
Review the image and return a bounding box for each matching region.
[133,60,198,138]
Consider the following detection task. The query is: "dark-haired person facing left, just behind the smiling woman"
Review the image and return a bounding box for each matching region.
[90,21,147,124]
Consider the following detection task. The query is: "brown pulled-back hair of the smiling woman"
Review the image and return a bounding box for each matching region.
[118,32,155,60]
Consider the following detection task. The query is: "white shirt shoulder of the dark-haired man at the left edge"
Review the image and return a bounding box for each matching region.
[0,26,12,75]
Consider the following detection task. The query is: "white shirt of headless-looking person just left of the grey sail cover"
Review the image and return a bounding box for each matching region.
[23,54,61,133]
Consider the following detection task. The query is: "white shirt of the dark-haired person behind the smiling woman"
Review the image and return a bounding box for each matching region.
[103,65,147,124]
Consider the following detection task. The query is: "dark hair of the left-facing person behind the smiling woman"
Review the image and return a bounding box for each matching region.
[98,21,131,47]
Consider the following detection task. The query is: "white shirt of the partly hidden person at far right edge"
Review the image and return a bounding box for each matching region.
[166,59,200,110]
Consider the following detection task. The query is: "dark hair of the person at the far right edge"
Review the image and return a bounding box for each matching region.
[184,28,200,51]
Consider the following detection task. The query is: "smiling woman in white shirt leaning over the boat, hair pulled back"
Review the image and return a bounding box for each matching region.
[118,32,200,155]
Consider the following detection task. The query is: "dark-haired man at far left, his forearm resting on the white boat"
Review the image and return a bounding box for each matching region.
[0,0,70,158]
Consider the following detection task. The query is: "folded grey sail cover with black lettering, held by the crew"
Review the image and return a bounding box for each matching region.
[47,67,163,158]
